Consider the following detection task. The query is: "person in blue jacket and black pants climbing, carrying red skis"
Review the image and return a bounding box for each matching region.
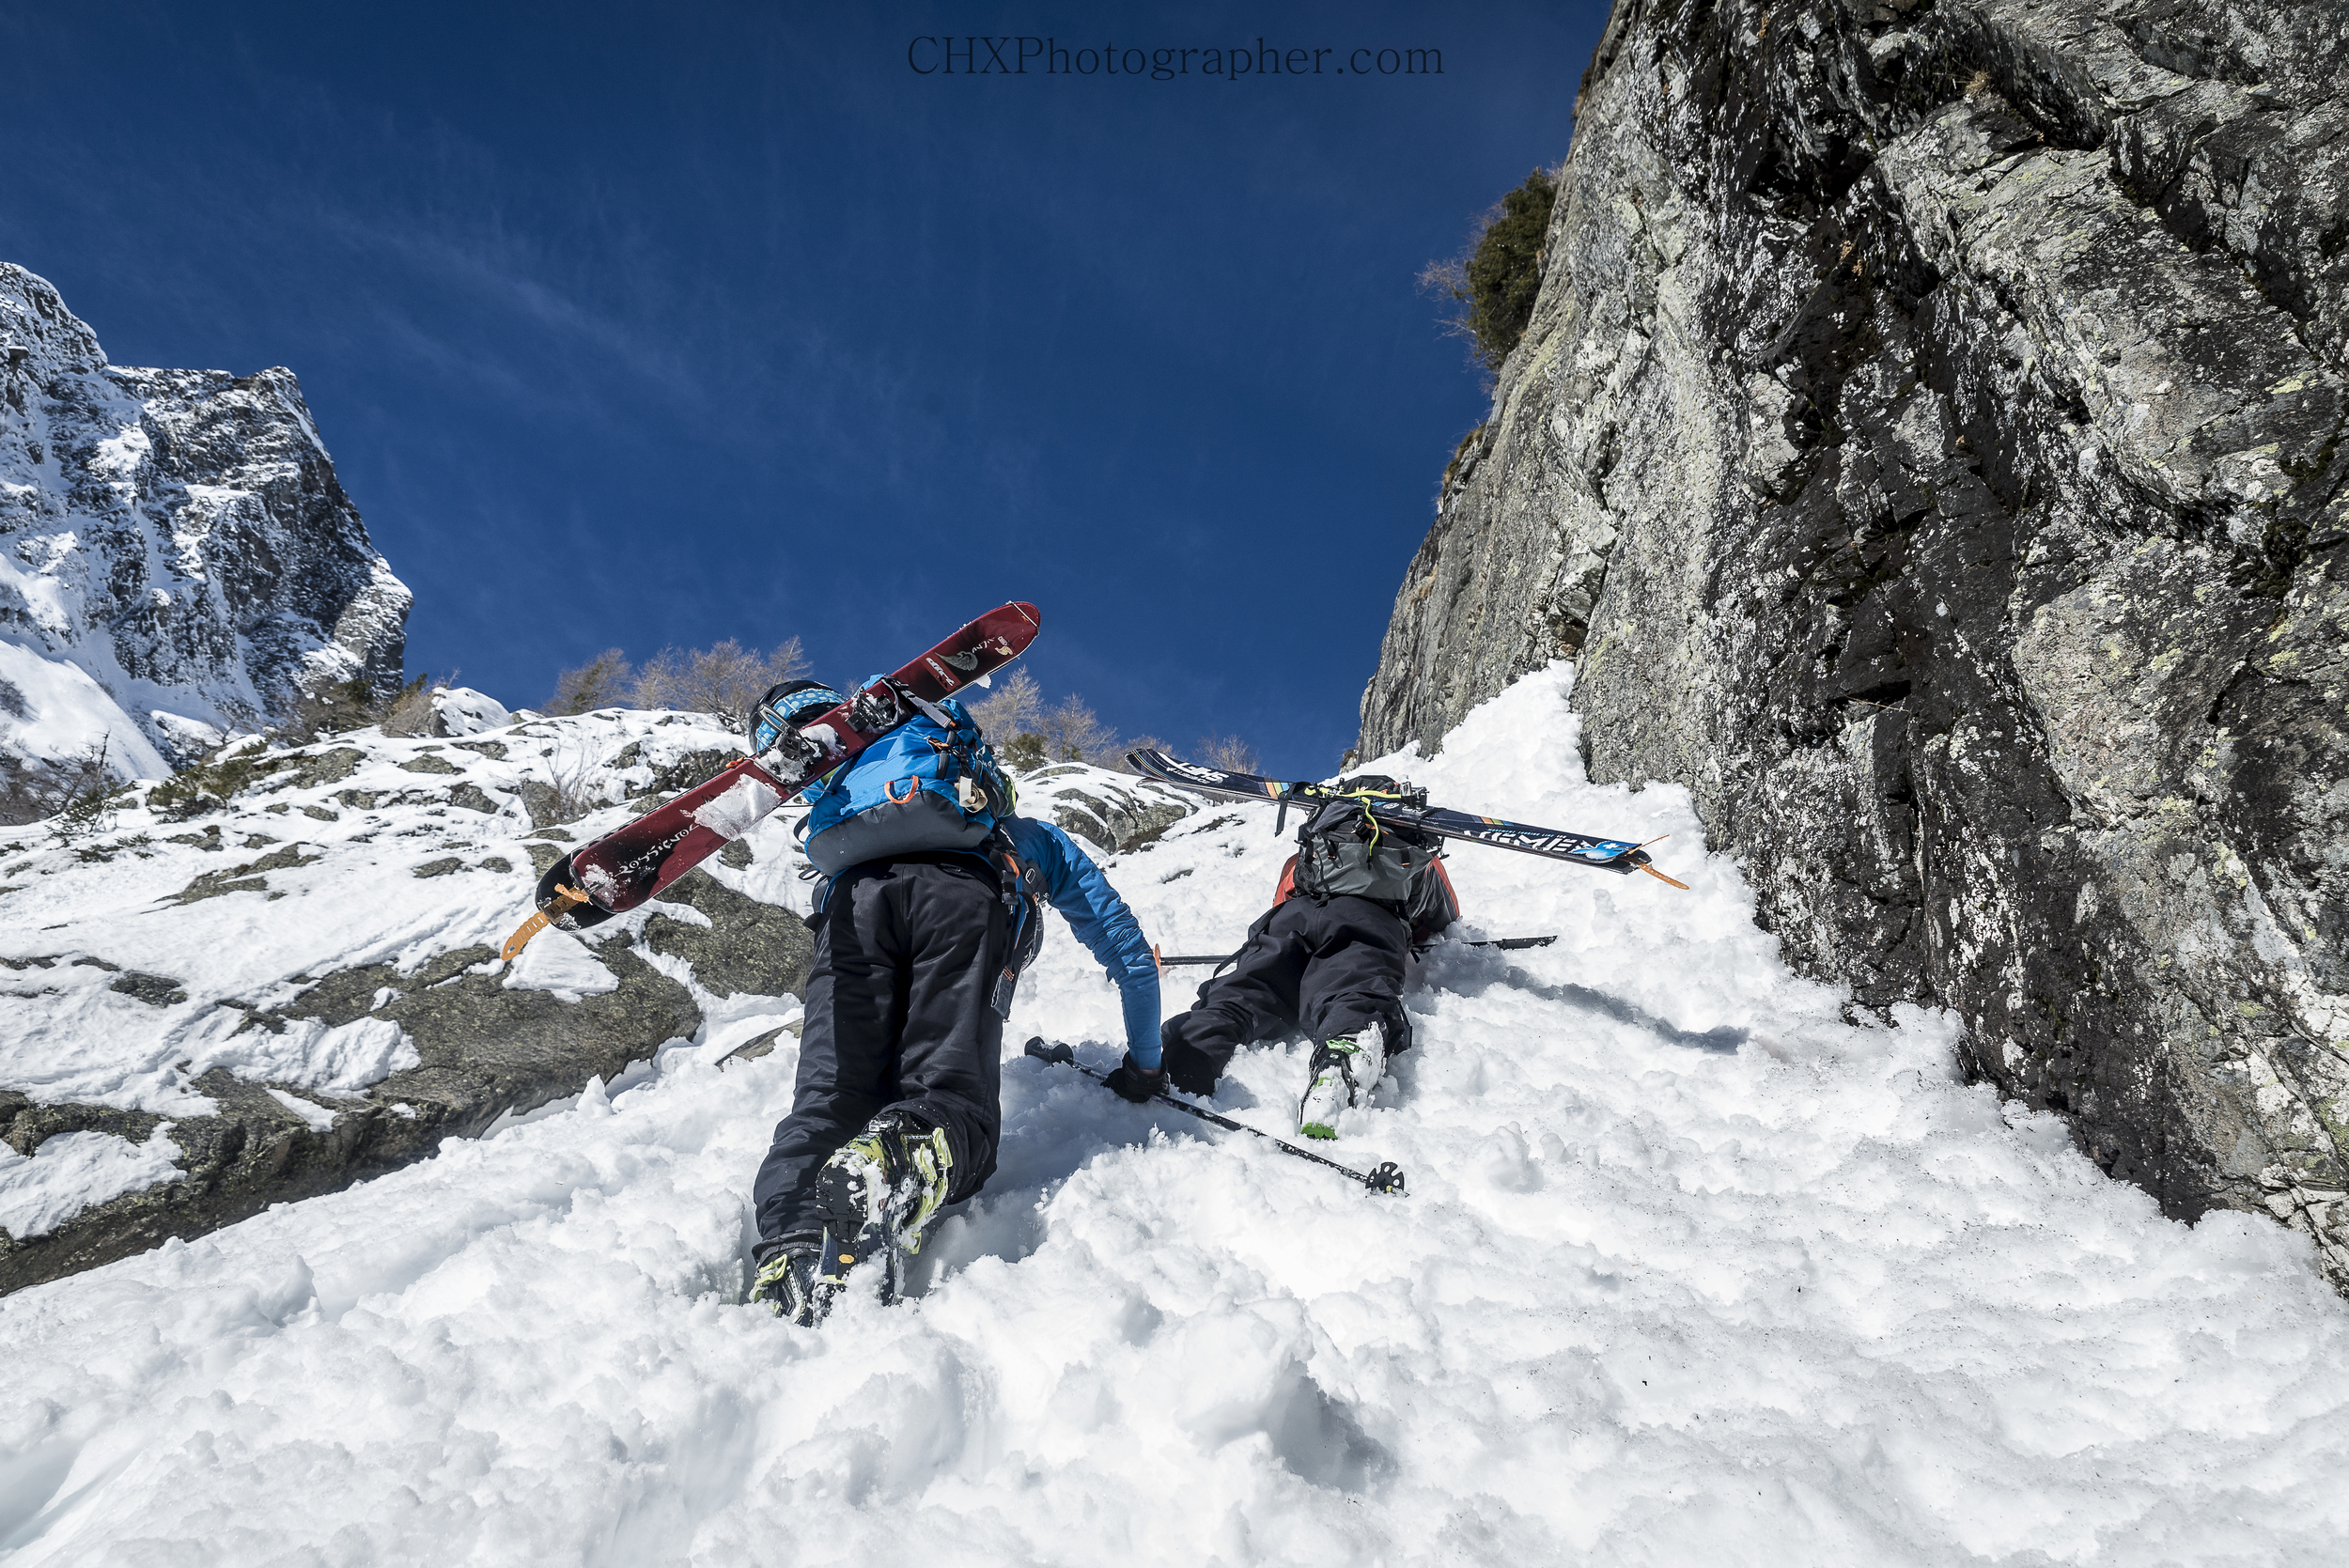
[752,681,1165,1324]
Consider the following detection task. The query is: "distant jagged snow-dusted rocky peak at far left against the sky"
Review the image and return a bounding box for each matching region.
[0,263,412,777]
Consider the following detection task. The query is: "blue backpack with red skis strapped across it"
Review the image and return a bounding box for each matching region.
[803,697,1018,876]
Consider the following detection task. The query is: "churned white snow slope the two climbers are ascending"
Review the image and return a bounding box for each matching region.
[0,672,2349,1566]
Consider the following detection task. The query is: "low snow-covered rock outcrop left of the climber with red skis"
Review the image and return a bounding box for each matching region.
[0,700,813,1291]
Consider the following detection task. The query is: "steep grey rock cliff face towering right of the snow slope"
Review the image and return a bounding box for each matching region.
[1362,0,2349,1289]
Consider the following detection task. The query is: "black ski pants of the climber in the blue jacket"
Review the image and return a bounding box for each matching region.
[752,854,1008,1251]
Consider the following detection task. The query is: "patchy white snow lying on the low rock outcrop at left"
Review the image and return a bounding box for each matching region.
[0,709,747,1126]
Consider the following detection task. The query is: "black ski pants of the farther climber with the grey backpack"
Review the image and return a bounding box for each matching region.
[1159,894,1412,1094]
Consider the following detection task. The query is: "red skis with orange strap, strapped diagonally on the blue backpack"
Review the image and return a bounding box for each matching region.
[506,603,1043,957]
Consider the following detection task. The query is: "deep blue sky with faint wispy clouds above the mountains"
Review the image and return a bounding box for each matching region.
[0,2,1605,775]
